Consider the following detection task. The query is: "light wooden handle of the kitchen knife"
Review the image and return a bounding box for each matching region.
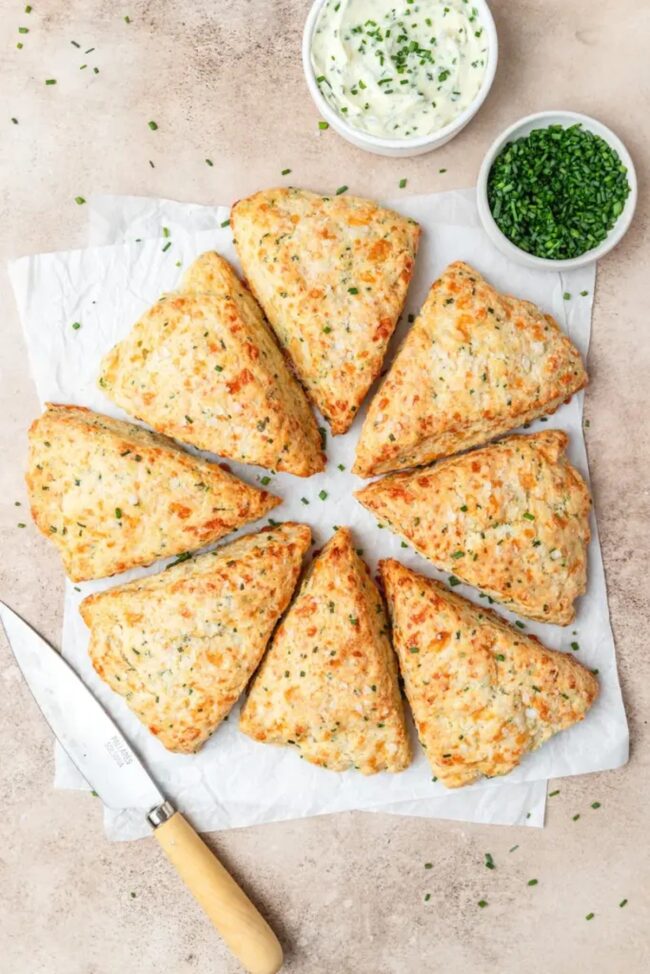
[154,812,282,974]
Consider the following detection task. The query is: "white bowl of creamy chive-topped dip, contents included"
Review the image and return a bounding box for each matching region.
[302,0,498,156]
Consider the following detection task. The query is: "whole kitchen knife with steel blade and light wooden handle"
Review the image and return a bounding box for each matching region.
[0,602,282,974]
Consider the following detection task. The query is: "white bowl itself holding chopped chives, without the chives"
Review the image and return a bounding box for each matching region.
[476,111,637,271]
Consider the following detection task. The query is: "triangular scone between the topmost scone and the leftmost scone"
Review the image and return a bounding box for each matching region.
[99,253,324,477]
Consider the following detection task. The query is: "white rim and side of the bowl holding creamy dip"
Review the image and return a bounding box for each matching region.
[302,0,499,158]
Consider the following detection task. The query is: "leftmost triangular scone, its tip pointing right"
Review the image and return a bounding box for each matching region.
[26,403,280,582]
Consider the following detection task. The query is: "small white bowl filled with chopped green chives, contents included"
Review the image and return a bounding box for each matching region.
[476,111,637,270]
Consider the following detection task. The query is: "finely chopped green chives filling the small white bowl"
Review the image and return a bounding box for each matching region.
[487,123,630,264]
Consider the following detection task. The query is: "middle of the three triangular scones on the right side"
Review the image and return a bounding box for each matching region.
[356,430,591,626]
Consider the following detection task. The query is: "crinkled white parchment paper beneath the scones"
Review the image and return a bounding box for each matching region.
[11,194,628,838]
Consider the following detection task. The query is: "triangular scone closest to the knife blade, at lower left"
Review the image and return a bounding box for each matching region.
[80,522,311,753]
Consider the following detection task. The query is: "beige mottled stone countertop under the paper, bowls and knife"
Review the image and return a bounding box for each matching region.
[0,0,650,974]
